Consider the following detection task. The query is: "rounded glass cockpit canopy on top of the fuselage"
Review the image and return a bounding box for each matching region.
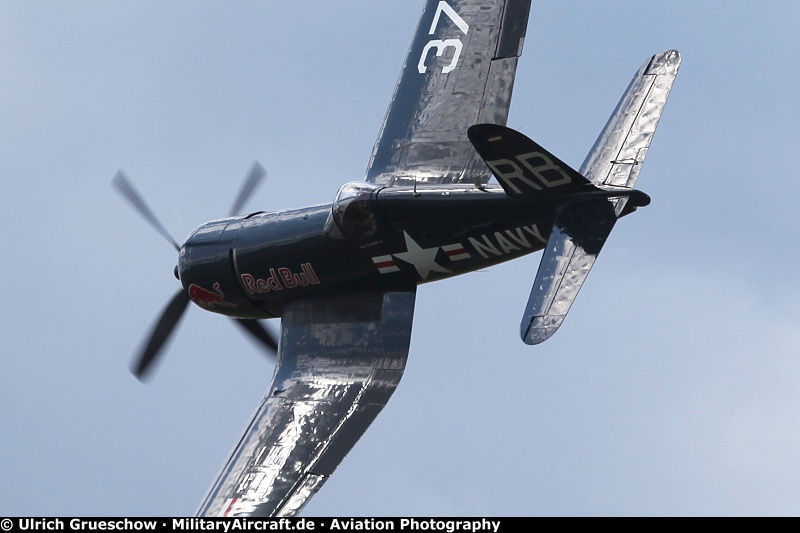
[331,181,382,240]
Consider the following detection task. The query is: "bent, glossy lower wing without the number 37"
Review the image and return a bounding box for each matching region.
[197,290,416,516]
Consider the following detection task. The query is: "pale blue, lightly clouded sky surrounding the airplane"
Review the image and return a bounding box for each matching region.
[0,0,800,516]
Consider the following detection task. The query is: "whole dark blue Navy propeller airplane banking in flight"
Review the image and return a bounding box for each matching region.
[113,0,681,517]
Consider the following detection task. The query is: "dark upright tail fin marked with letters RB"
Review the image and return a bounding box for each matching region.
[467,124,595,199]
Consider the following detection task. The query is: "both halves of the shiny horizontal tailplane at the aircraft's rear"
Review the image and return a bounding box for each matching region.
[520,50,681,344]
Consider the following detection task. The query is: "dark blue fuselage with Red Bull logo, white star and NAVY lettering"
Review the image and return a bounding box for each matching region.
[178,182,558,318]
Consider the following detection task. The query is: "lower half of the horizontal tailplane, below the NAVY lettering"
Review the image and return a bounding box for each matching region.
[520,198,617,344]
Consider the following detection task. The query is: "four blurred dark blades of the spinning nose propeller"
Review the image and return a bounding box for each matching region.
[112,162,278,381]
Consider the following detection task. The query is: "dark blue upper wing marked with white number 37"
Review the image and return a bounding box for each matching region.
[366,0,531,186]
